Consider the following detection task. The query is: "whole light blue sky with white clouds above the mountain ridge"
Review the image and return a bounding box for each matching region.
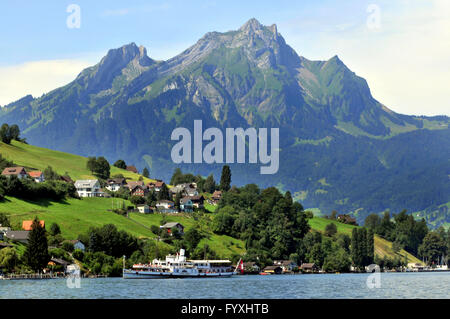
[0,0,450,115]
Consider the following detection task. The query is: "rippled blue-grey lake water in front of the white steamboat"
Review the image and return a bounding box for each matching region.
[0,272,450,299]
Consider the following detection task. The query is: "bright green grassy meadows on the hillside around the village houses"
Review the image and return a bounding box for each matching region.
[0,141,420,262]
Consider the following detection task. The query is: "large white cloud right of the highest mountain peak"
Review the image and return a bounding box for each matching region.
[281,0,450,115]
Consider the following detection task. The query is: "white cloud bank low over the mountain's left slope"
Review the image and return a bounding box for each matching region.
[0,59,94,105]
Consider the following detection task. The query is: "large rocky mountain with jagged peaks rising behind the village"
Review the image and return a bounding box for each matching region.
[0,19,450,226]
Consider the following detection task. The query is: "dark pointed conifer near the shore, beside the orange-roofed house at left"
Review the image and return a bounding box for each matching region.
[24,217,50,272]
